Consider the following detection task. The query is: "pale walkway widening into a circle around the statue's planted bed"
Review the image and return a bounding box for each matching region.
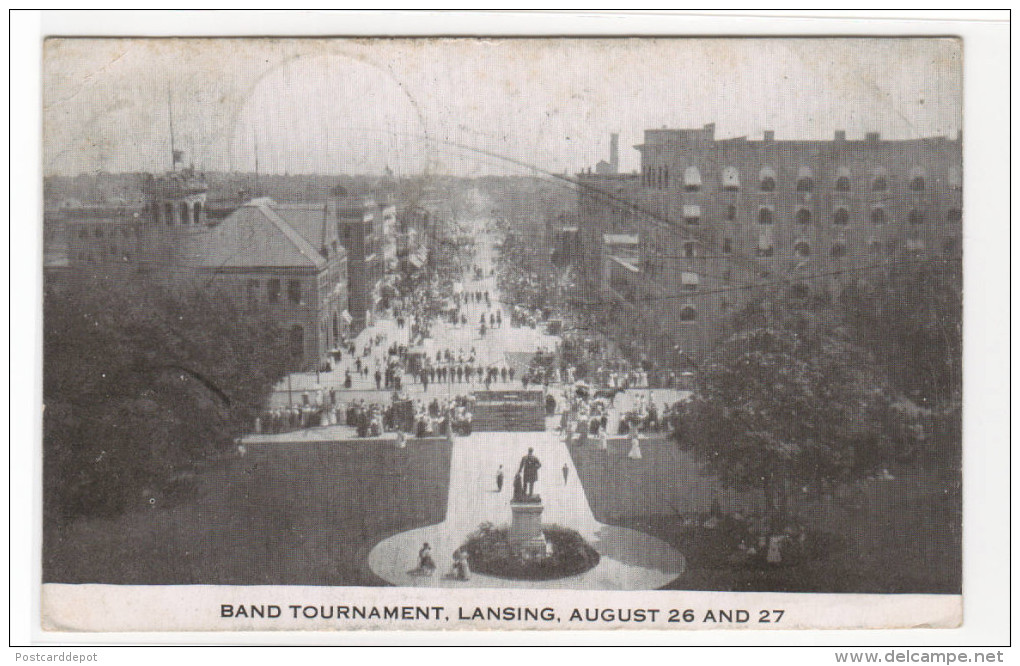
[368,432,684,590]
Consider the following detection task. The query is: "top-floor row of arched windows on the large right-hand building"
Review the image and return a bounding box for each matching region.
[642,166,963,192]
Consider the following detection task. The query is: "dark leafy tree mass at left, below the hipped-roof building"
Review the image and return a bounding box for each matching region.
[43,276,289,519]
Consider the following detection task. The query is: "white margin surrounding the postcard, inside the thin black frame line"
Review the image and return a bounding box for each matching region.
[8,11,1010,645]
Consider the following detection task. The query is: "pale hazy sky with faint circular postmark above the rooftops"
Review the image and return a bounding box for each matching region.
[43,38,963,175]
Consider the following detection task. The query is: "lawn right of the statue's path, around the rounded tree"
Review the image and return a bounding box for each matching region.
[570,440,962,594]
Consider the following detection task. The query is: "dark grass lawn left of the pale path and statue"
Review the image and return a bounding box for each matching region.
[43,441,450,585]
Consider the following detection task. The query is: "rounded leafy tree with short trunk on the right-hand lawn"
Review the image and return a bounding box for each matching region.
[684,301,887,533]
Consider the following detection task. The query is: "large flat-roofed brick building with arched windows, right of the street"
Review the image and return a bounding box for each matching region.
[576,124,962,357]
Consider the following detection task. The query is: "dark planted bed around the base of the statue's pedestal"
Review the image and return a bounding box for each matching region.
[461,523,600,580]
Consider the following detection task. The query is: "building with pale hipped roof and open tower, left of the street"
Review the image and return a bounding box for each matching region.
[63,170,352,369]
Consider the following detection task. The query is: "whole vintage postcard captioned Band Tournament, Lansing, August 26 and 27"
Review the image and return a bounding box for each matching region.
[41,37,964,631]
